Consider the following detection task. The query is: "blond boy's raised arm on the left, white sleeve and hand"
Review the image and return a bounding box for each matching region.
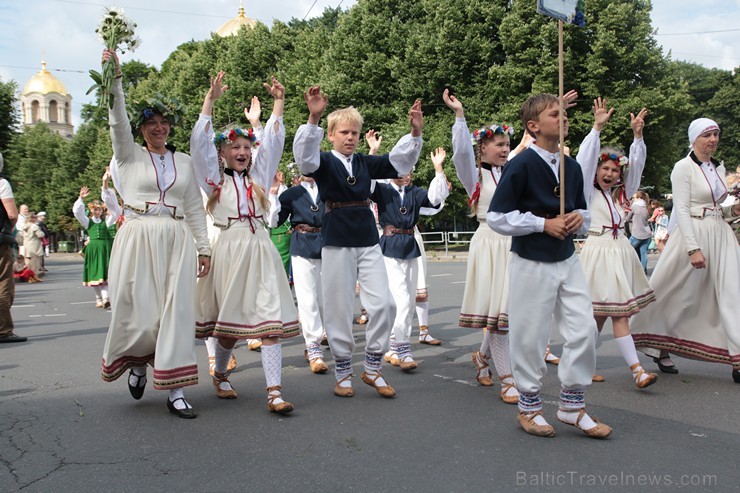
[293,86,329,175]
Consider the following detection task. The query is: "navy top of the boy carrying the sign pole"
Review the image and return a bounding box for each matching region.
[488,149,588,262]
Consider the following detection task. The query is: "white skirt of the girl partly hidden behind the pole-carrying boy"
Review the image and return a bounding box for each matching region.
[458,223,511,330]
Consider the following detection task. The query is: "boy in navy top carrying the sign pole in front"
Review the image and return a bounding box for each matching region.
[487,94,611,438]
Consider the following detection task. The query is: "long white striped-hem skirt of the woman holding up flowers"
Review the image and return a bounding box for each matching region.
[102,215,198,389]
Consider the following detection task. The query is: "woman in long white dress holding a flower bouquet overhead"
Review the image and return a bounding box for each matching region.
[102,50,211,418]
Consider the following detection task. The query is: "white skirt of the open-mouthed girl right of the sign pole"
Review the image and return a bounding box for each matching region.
[580,234,655,317]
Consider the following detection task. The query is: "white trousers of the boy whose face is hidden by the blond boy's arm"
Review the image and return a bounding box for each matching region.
[383,257,419,343]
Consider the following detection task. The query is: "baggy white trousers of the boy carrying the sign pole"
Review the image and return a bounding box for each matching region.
[509,252,597,392]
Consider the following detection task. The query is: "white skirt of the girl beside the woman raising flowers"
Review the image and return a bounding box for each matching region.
[196,221,300,339]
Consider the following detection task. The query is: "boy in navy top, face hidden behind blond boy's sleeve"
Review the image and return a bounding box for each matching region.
[371,147,450,371]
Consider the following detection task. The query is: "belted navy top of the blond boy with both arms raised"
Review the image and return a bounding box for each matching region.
[308,152,398,247]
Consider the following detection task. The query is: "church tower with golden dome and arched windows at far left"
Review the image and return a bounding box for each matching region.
[21,61,74,139]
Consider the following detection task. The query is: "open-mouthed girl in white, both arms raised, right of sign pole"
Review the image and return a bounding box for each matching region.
[577,98,658,389]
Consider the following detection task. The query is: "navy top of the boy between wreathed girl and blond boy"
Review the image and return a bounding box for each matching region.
[278,185,324,258]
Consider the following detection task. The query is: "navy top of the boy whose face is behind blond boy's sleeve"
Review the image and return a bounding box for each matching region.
[372,183,439,260]
